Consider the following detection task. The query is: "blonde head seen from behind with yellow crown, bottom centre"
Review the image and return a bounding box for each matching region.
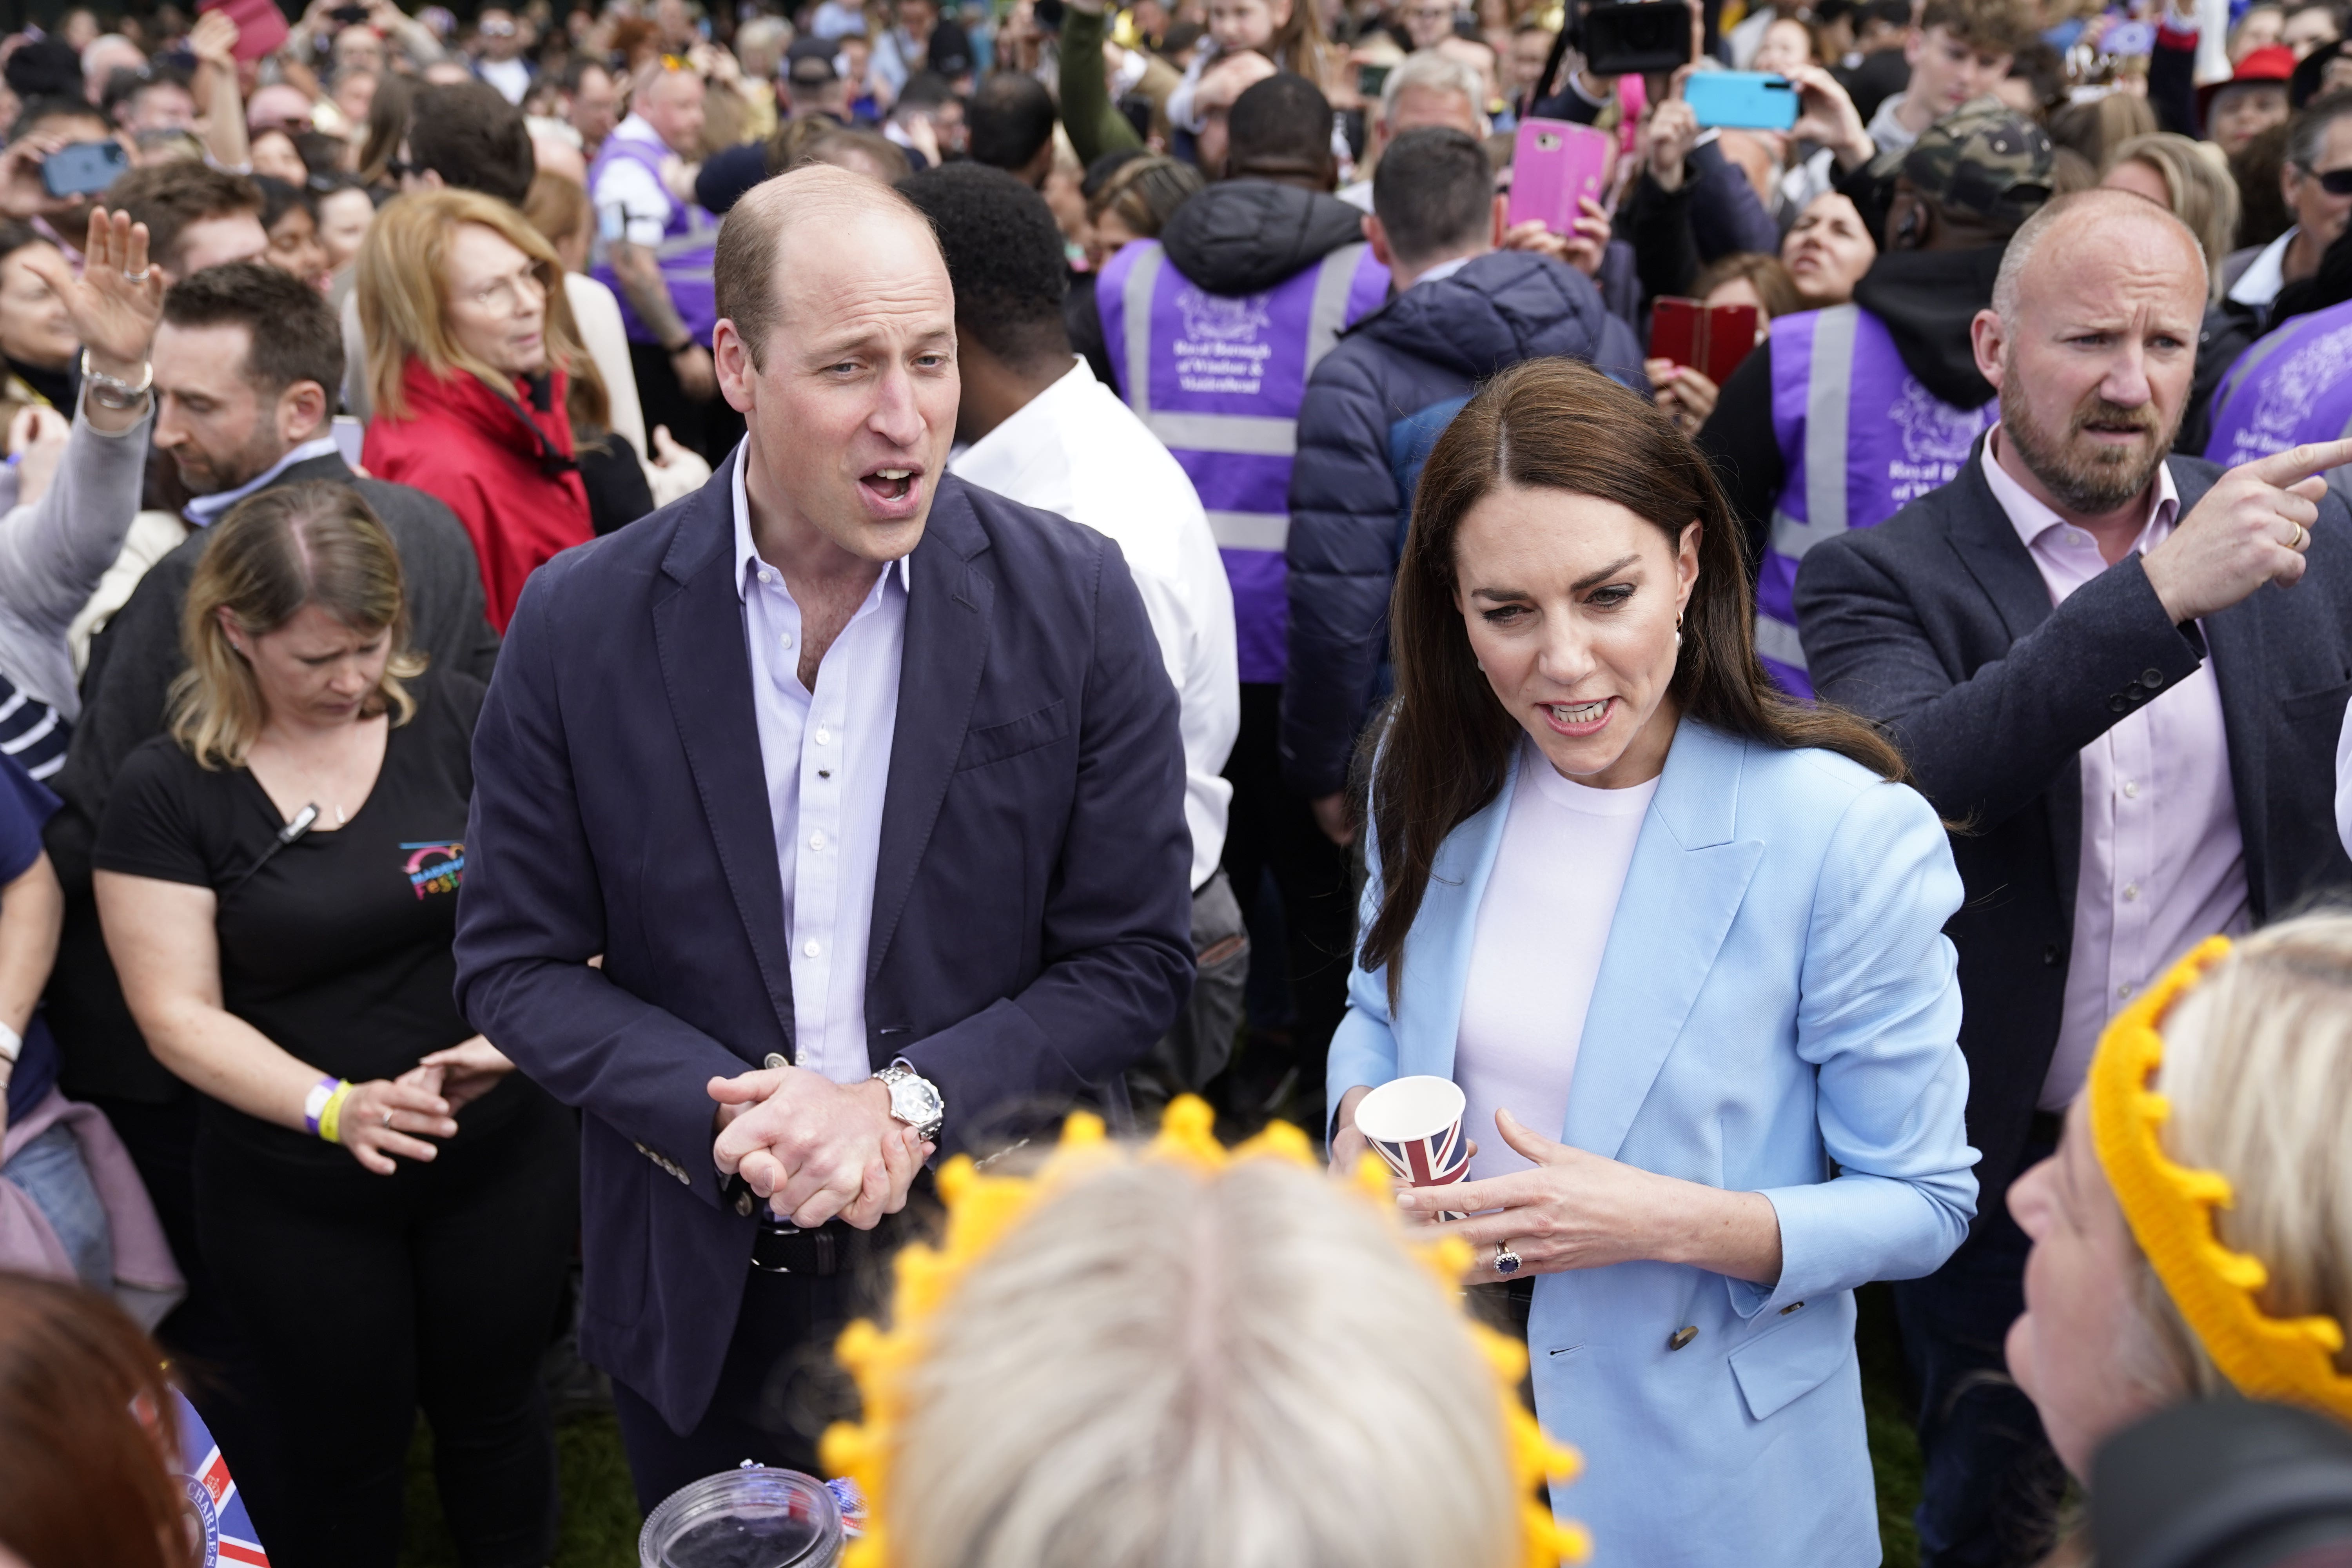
[826,1100,1543,1568]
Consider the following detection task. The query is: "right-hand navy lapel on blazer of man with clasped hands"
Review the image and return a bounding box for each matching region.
[866,477,995,983]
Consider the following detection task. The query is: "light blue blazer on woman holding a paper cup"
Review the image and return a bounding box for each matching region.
[1329,719,1976,1568]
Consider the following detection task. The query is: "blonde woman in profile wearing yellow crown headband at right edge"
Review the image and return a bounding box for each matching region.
[2009,915,2352,1476]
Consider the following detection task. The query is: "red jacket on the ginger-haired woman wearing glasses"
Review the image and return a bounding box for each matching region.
[360,358,595,637]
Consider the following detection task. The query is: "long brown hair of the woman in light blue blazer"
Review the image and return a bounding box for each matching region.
[1359,360,1903,1006]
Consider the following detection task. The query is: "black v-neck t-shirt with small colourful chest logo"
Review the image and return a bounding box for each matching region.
[92,672,513,1159]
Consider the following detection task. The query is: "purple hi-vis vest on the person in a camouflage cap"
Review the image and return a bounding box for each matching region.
[1757,306,1999,698]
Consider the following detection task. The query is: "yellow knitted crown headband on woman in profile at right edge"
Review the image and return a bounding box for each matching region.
[2091,936,2352,1422]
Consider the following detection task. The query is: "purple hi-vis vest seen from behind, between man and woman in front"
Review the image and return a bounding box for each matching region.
[1094,240,1388,682]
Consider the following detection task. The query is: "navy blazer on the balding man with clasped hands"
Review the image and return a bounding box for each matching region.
[456,458,1192,1432]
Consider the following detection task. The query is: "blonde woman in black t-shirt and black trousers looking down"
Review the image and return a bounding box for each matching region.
[94,484,579,1568]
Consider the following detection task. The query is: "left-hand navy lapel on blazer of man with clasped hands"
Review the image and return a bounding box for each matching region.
[654,449,793,1039]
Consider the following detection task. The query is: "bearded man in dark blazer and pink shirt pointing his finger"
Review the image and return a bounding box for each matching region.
[1797,191,2352,1566]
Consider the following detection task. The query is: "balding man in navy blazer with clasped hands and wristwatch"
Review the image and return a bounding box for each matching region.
[459,167,1192,1507]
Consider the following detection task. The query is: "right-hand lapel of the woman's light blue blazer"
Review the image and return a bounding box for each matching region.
[1559,719,1764,1159]
